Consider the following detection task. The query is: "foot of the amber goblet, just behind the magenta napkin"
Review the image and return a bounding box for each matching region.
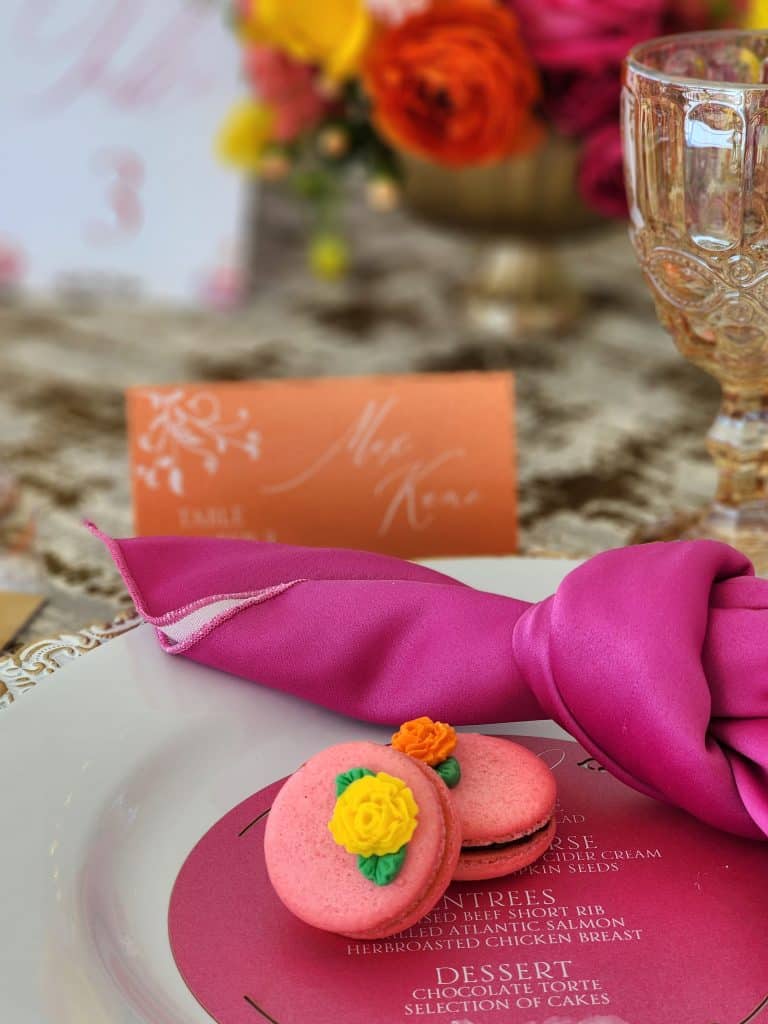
[631,502,768,578]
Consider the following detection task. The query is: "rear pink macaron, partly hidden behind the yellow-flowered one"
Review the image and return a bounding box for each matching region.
[451,732,557,879]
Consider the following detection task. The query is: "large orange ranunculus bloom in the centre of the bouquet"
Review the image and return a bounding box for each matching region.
[364,0,543,167]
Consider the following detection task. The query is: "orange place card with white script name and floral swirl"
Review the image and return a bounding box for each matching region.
[128,373,517,557]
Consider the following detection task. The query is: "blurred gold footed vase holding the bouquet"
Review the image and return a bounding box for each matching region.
[403,135,602,342]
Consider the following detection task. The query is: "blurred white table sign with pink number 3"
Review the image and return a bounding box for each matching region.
[0,0,239,300]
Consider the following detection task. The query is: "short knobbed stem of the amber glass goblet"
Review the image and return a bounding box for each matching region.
[707,387,768,536]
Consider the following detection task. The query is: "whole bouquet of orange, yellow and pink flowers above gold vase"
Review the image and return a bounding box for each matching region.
[218,0,740,276]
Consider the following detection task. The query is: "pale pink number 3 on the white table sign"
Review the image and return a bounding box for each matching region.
[85,147,145,245]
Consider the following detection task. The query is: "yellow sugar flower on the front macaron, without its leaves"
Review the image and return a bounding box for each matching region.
[328,771,419,857]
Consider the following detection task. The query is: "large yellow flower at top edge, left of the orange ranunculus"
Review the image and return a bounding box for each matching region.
[243,0,373,81]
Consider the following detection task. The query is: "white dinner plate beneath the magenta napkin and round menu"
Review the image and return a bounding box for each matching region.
[0,558,577,1024]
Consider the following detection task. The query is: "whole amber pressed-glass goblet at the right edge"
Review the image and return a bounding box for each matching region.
[623,31,768,572]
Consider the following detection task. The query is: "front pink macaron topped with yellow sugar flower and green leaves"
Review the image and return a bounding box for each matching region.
[264,741,462,939]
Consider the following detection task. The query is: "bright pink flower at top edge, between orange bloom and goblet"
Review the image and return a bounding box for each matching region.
[514,0,666,71]
